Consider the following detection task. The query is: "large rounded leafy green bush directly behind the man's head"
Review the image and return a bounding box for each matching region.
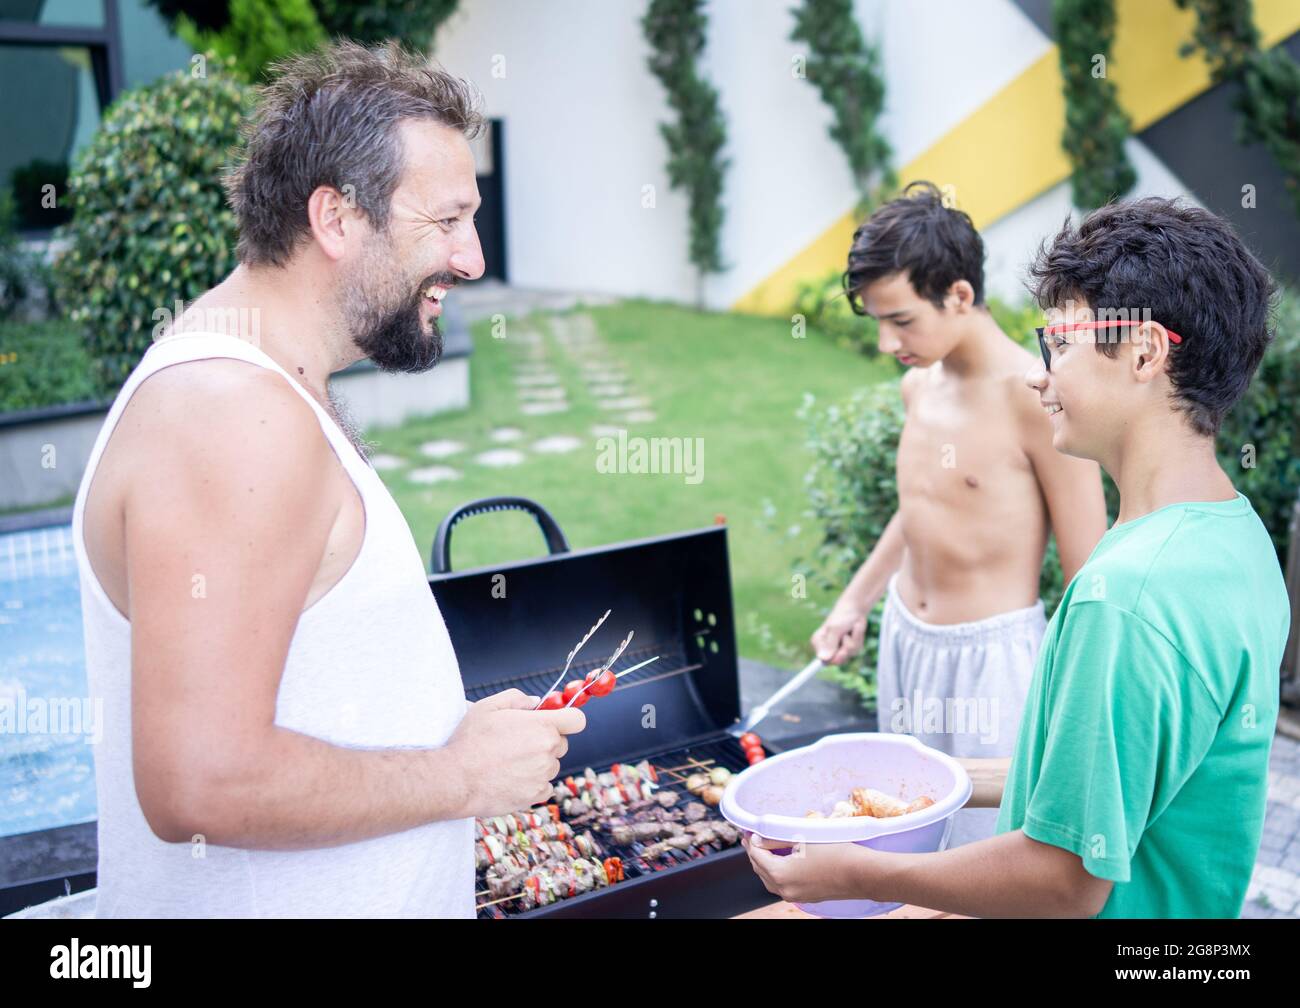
[55,56,251,395]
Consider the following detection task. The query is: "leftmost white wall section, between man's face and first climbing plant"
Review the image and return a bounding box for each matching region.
[434,0,694,300]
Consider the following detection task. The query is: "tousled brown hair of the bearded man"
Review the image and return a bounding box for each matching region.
[222,40,484,265]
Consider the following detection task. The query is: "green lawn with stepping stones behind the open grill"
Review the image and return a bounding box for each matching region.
[367,302,894,667]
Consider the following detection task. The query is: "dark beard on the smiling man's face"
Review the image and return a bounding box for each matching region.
[343,232,456,375]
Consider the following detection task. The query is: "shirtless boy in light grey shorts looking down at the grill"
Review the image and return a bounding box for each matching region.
[813,182,1106,847]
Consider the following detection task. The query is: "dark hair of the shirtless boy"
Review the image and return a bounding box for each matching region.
[842,182,984,315]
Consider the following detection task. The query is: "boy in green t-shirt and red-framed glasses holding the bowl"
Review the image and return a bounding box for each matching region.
[746,198,1291,917]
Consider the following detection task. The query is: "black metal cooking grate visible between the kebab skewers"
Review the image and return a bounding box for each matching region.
[476,733,749,920]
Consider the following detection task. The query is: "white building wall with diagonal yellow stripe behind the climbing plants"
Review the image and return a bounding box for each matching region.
[436,0,1300,313]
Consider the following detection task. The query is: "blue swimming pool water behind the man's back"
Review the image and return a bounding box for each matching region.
[0,525,95,836]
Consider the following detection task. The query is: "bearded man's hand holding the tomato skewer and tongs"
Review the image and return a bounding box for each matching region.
[446,689,586,816]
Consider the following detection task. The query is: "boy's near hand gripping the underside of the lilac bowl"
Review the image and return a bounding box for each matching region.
[741,834,889,903]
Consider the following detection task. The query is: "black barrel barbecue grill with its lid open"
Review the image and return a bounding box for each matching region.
[429,497,772,918]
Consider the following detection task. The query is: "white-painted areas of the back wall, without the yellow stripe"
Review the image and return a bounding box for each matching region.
[436,0,1190,307]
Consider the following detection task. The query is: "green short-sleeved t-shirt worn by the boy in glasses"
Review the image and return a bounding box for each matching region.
[997,493,1291,917]
